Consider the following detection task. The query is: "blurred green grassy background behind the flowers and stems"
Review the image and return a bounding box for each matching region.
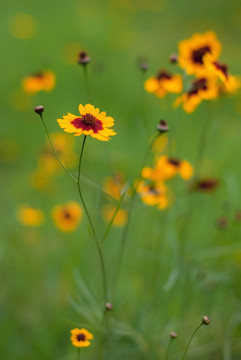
[0,0,241,360]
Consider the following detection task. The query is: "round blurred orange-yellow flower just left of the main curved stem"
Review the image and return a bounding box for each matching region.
[52,201,82,232]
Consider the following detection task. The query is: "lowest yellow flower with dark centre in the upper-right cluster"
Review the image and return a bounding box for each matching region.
[174,77,219,113]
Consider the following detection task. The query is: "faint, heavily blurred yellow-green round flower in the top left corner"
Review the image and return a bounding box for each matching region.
[9,13,37,39]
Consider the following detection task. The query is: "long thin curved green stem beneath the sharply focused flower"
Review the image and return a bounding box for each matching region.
[77,135,108,302]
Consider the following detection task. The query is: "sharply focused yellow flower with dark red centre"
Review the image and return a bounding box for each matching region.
[57,104,116,141]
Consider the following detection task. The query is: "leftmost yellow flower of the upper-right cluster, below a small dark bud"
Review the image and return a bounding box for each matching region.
[144,70,182,97]
